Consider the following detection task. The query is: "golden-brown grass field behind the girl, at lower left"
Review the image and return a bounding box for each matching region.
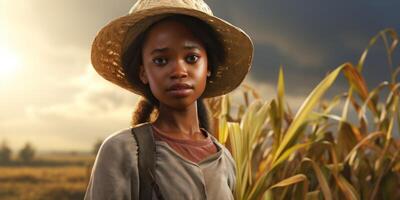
[0,155,94,200]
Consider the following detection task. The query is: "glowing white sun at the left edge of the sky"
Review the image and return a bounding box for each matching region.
[0,46,20,81]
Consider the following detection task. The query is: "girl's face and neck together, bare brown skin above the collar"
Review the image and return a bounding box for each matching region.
[139,20,208,140]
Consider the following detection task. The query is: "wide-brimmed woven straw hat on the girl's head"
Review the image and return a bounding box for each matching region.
[91,0,253,97]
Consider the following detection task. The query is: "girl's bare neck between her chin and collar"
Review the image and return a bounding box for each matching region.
[153,101,200,135]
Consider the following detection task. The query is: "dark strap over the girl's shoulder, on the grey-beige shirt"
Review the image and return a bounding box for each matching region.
[132,124,164,200]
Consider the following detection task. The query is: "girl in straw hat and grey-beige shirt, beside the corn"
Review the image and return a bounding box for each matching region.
[85,0,253,200]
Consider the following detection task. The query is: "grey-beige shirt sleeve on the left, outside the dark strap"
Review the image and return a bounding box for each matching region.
[84,133,139,200]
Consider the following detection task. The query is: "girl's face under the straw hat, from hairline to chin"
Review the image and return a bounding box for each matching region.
[140,20,208,109]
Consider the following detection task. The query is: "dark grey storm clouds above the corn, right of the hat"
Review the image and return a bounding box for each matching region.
[206,0,400,95]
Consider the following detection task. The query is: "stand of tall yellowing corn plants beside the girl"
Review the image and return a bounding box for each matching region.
[208,29,400,200]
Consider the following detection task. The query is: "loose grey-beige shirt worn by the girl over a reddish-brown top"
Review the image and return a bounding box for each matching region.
[85,123,236,200]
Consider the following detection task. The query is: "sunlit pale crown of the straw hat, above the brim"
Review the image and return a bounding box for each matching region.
[129,0,213,15]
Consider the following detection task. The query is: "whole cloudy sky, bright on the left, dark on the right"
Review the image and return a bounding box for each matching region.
[0,0,400,151]
